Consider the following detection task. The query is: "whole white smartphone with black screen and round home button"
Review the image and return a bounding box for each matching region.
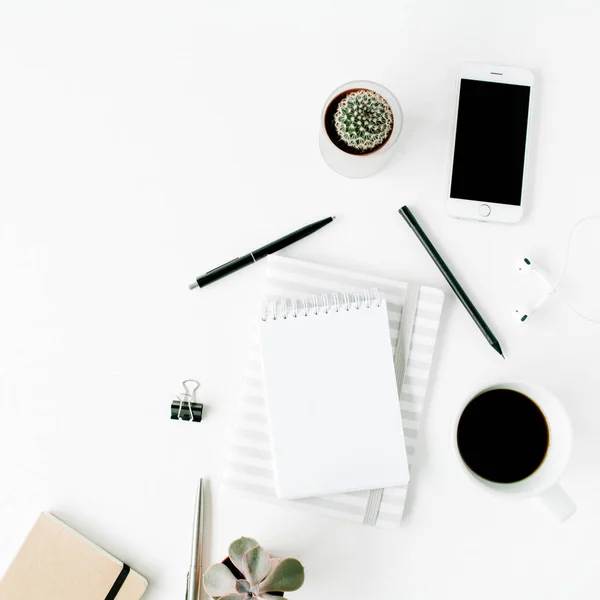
[446,63,534,223]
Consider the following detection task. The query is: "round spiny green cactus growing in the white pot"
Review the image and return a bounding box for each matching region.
[333,90,394,151]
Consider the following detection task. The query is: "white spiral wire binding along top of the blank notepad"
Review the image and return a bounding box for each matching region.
[260,288,381,322]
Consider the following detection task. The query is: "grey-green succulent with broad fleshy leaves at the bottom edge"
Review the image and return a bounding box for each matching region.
[203,537,304,600]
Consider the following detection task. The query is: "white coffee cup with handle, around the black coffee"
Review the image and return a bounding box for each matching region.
[452,383,577,522]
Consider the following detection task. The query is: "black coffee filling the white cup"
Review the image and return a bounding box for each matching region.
[456,390,550,483]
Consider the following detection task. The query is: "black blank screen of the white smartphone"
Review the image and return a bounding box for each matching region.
[450,79,531,206]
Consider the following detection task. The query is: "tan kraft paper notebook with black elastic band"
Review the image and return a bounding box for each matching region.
[0,513,148,600]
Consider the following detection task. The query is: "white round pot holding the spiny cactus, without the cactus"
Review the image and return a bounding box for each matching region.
[319,80,403,178]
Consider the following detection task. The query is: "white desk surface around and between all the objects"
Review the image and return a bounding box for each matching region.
[0,0,600,600]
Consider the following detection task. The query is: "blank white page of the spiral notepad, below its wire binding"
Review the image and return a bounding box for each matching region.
[260,300,409,499]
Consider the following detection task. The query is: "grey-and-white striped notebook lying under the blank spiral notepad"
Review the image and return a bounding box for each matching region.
[223,256,444,527]
